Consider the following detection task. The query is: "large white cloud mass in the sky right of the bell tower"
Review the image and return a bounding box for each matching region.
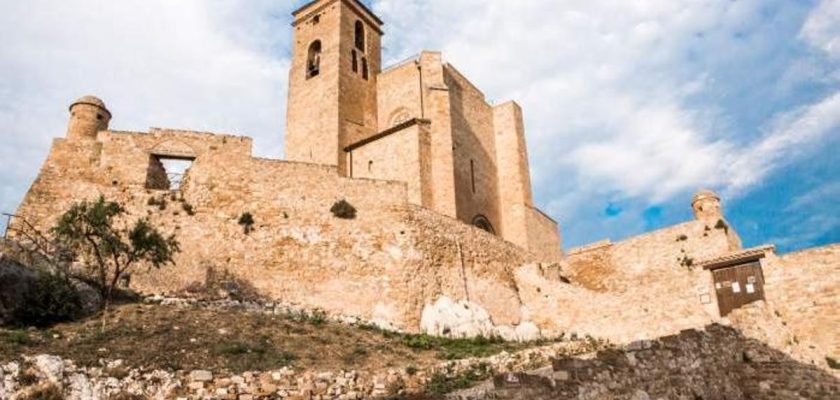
[377,0,840,218]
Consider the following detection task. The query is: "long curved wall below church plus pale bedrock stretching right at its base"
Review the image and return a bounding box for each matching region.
[14,129,748,341]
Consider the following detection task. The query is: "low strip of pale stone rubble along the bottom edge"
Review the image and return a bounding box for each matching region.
[0,342,600,400]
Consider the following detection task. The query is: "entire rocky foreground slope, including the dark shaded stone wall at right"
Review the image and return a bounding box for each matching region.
[0,299,840,400]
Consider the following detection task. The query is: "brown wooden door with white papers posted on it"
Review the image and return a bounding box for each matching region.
[712,261,764,317]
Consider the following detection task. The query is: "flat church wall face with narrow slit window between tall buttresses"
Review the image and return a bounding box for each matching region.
[443,64,505,235]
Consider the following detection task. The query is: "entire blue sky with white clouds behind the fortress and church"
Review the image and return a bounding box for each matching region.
[0,0,840,252]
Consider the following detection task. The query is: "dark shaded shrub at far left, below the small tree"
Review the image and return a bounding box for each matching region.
[15,273,82,327]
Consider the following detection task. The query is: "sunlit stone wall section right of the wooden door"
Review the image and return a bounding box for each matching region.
[762,245,840,359]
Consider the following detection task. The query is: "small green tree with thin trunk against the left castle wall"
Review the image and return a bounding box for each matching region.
[52,196,181,308]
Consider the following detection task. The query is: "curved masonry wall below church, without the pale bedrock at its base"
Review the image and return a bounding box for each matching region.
[13,131,544,330]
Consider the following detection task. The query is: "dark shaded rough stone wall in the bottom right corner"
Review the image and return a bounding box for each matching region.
[486,325,840,400]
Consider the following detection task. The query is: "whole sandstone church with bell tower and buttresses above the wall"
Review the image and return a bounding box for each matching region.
[286,0,561,258]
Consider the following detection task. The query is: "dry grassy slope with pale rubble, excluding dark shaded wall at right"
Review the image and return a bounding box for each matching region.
[0,298,604,400]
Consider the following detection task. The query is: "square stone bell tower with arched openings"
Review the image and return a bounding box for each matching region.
[285,0,383,174]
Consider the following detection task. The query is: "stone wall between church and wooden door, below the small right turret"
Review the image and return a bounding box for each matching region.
[565,221,740,331]
